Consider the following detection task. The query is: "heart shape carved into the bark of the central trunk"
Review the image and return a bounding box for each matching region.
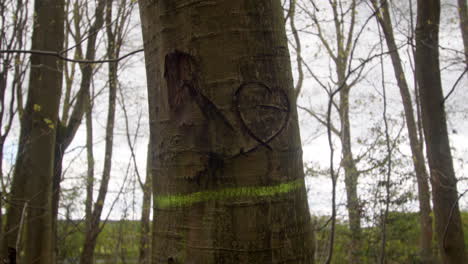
[234,82,290,153]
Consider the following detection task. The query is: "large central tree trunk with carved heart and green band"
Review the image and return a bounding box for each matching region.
[140,0,313,264]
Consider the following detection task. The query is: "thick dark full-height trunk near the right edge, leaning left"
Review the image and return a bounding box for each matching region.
[416,0,468,264]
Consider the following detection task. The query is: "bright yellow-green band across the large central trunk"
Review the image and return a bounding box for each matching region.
[156,179,304,208]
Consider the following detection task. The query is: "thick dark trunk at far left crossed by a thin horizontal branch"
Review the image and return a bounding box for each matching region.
[2,0,64,264]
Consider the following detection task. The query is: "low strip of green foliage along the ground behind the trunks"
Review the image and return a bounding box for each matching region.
[57,212,468,264]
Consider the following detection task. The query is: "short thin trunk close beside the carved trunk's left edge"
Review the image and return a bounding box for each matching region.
[138,143,153,264]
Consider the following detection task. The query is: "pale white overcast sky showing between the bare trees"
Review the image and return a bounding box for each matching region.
[5,0,468,222]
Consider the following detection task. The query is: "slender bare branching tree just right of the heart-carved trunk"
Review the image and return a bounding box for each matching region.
[291,0,372,263]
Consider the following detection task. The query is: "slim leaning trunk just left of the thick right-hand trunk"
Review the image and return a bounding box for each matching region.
[372,0,434,263]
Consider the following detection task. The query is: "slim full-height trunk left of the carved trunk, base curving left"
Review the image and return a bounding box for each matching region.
[80,0,118,264]
